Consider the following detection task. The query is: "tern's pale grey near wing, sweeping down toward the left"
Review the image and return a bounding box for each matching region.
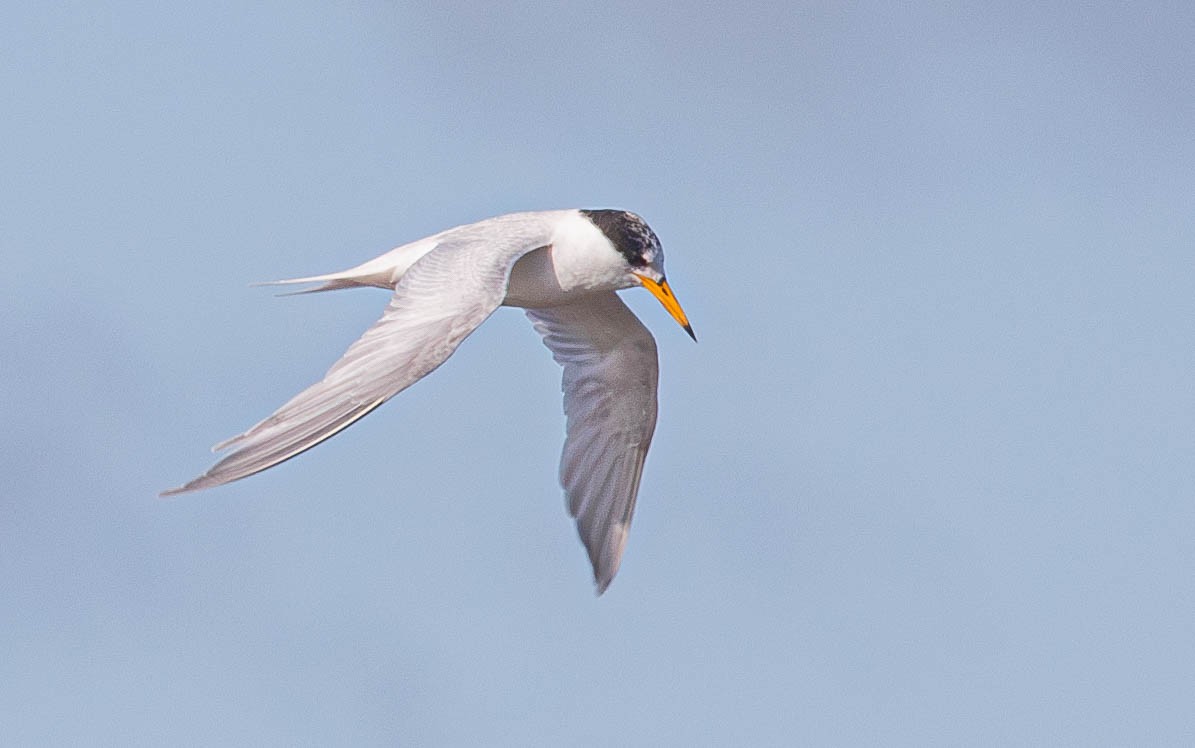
[163,222,549,496]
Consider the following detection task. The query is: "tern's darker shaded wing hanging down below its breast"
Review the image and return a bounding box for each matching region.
[527,292,660,594]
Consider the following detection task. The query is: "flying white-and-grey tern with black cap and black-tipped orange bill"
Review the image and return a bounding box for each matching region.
[161,209,697,595]
